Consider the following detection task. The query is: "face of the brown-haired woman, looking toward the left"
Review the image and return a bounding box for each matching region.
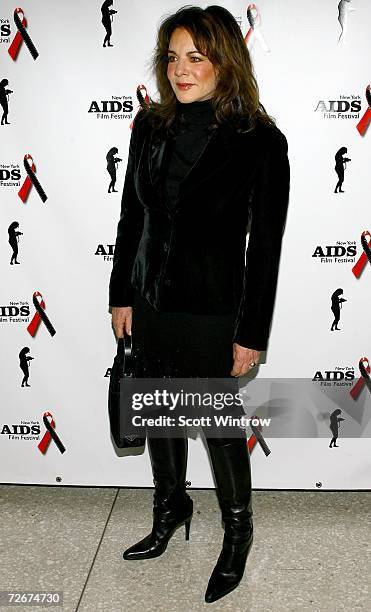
[167,28,216,103]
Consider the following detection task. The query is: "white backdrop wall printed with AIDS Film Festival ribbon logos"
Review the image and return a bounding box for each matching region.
[0,0,371,489]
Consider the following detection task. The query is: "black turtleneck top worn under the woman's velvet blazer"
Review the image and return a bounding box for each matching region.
[165,99,215,206]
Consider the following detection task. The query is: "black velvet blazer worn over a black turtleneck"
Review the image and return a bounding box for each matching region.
[109,111,290,350]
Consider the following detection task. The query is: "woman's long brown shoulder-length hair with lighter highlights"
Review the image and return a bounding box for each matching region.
[149,5,275,129]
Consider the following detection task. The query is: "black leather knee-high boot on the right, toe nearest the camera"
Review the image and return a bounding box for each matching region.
[205,438,253,603]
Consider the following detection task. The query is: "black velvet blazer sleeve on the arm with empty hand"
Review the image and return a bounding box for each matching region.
[234,128,290,351]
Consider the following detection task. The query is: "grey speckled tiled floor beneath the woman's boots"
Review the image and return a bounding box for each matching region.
[0,485,371,612]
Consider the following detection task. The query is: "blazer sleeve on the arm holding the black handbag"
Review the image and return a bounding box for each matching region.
[109,111,144,306]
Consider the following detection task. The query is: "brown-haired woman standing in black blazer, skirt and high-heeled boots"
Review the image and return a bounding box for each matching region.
[109,6,289,602]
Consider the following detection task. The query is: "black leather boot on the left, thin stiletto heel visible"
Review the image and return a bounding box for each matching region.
[123,437,193,559]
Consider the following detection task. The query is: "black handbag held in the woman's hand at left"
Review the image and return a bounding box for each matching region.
[108,334,146,448]
